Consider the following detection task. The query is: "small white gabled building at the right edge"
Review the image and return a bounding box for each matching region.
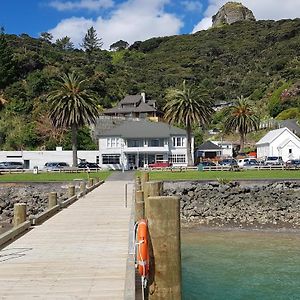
[256,127,300,162]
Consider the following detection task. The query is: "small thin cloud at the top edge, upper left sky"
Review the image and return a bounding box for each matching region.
[49,0,114,11]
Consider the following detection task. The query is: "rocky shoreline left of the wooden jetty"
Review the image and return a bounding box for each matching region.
[0,183,72,234]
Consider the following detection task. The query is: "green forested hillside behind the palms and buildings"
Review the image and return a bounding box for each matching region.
[0,19,300,149]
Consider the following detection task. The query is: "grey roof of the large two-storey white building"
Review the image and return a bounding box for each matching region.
[99,119,186,138]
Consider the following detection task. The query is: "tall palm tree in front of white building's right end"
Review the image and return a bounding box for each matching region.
[163,81,213,166]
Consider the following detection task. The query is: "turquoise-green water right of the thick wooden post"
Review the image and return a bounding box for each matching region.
[182,231,300,300]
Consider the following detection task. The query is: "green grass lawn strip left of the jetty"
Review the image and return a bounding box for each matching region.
[0,171,111,182]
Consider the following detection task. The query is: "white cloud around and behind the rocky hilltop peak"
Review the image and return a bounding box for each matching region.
[193,0,300,32]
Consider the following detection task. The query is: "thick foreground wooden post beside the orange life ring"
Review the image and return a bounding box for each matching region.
[145,196,181,300]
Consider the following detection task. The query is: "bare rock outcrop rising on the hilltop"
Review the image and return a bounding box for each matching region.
[212,2,255,27]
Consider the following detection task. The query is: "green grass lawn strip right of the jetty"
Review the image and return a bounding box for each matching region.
[150,170,300,180]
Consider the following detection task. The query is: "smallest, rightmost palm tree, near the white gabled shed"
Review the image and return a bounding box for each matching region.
[224,96,259,151]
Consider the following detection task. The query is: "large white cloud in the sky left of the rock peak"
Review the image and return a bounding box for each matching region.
[49,0,183,49]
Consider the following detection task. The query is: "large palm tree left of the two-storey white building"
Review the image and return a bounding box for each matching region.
[47,72,99,167]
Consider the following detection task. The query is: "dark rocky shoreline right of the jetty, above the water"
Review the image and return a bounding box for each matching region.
[164,181,300,230]
